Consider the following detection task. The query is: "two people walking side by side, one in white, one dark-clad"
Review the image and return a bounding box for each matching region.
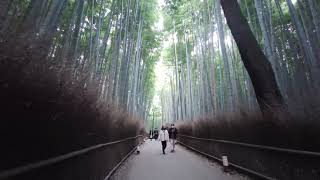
[158,124,178,154]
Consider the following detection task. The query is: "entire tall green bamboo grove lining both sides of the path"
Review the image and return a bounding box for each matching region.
[0,0,320,124]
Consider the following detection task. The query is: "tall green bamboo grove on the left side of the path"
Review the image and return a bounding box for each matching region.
[0,0,161,121]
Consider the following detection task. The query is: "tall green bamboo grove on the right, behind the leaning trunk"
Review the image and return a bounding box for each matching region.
[162,0,320,121]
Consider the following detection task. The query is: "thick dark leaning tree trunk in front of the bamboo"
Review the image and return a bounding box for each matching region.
[221,0,287,120]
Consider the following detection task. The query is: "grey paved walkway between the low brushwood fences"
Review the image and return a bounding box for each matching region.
[112,140,248,180]
